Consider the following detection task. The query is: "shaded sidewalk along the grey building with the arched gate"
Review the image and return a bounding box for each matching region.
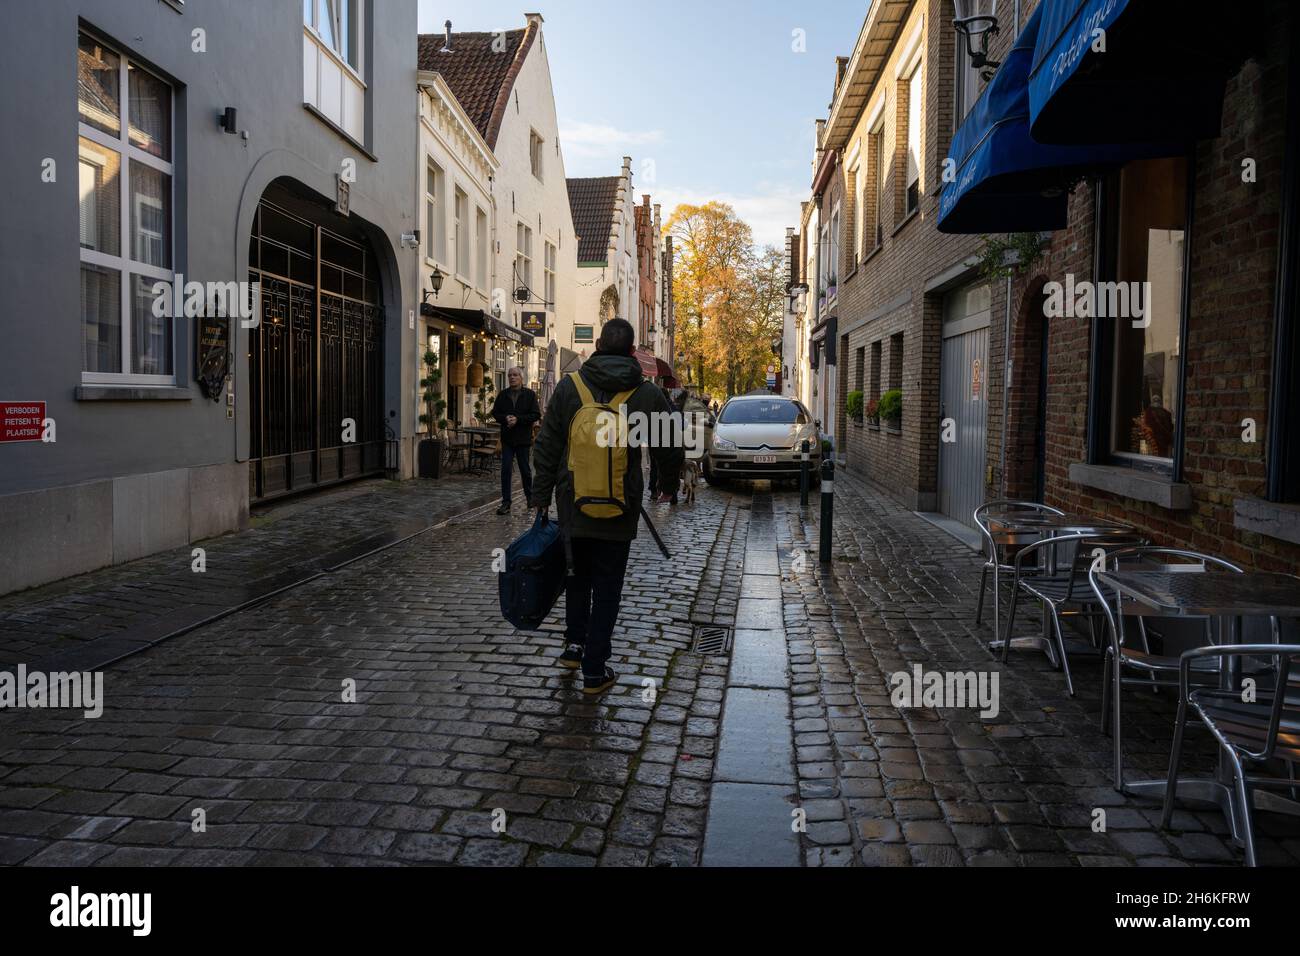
[0,475,499,670]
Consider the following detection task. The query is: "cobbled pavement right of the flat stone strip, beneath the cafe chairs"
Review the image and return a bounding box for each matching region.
[777,475,1300,866]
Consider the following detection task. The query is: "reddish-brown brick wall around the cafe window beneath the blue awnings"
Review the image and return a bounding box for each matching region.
[1008,3,1300,572]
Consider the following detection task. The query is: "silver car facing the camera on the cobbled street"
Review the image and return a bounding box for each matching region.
[705,395,822,485]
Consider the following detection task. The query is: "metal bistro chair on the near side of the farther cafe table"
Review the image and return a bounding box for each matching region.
[1002,528,1147,697]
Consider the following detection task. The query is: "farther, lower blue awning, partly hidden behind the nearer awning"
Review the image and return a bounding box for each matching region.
[939,0,1183,233]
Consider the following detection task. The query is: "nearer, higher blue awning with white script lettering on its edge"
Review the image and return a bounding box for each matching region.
[1030,0,1255,143]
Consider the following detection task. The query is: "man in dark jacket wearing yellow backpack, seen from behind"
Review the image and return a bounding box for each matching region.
[530,319,685,696]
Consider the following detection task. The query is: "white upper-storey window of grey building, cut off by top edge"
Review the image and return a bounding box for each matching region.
[303,0,365,140]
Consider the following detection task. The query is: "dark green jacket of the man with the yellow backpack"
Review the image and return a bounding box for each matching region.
[530,354,685,541]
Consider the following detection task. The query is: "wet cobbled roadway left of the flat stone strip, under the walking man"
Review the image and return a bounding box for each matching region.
[0,478,748,866]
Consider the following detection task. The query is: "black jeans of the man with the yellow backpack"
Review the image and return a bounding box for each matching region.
[564,537,632,678]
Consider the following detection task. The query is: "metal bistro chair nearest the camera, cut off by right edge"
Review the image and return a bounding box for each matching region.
[1161,642,1300,866]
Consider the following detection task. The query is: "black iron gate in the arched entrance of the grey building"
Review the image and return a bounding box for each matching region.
[248,200,385,501]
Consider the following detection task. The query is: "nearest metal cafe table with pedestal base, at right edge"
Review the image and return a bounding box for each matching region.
[1097,571,1300,842]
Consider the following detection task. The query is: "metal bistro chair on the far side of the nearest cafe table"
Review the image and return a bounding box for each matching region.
[1088,548,1242,791]
